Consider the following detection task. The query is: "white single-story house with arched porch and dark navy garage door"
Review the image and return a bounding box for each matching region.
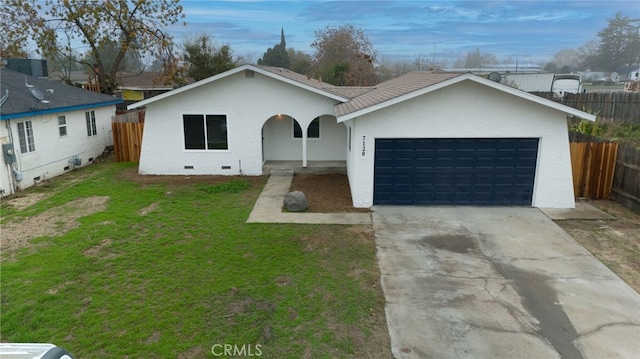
[129,65,595,208]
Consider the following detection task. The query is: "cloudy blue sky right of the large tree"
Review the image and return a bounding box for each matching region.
[169,0,640,65]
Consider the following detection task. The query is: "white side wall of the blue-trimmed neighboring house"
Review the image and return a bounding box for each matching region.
[0,106,115,195]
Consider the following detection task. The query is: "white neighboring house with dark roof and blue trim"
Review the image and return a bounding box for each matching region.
[0,69,122,196]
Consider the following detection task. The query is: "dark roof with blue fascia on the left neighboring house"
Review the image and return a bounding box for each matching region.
[0,69,123,120]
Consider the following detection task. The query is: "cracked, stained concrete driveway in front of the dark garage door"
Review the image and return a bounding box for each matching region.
[373,206,640,359]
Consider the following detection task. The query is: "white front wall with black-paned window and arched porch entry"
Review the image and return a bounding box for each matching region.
[139,71,344,175]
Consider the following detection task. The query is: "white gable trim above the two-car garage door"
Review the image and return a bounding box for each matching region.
[337,73,596,123]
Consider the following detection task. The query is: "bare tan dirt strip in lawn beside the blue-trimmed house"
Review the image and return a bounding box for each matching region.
[2,196,109,253]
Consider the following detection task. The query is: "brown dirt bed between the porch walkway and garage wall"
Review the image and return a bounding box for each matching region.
[291,174,369,213]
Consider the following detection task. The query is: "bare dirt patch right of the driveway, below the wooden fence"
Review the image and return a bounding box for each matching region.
[556,200,640,293]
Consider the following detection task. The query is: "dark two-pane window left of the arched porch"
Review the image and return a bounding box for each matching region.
[182,115,229,150]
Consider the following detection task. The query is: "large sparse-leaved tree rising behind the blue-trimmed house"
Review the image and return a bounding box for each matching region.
[2,0,184,94]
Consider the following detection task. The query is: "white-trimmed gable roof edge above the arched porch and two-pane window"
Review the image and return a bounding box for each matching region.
[127,65,349,109]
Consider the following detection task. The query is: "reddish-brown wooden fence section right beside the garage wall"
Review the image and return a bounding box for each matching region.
[570,142,618,199]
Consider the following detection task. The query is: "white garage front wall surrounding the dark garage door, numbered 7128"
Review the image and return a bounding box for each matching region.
[346,81,575,208]
